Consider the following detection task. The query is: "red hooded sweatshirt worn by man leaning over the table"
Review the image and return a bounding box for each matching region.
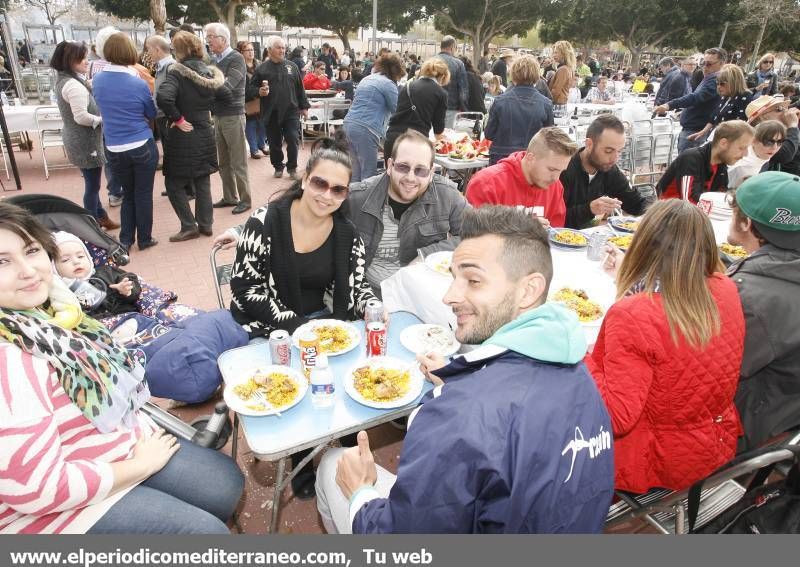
[467,151,567,228]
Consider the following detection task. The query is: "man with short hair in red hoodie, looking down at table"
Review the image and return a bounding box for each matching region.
[467,127,578,227]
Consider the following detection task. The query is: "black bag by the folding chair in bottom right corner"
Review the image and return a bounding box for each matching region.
[688,446,800,534]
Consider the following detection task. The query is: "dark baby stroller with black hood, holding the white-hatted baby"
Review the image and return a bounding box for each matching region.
[6,194,232,449]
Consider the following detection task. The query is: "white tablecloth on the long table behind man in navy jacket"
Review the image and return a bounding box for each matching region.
[381,220,729,346]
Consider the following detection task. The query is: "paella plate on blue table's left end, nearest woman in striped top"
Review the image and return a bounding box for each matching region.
[223,365,308,416]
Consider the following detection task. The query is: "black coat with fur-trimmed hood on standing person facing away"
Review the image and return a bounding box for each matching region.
[156,59,225,178]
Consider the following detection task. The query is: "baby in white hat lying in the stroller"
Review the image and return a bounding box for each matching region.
[53,231,142,318]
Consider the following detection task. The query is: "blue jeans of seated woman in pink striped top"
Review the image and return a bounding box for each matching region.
[88,441,244,534]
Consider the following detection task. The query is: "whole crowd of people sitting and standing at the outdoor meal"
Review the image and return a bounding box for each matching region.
[0,23,800,533]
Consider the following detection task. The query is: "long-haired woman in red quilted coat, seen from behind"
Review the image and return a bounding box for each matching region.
[585,199,744,493]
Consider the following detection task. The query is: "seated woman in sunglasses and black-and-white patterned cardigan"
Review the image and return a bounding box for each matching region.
[225,133,375,499]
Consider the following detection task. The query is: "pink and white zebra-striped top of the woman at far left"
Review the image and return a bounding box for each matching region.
[0,343,153,534]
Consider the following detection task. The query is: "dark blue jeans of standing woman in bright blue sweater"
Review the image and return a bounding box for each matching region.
[108,138,158,248]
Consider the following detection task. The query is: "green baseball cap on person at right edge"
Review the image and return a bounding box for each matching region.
[736,171,800,250]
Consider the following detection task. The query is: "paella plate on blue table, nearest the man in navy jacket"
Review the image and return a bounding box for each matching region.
[344,356,425,409]
